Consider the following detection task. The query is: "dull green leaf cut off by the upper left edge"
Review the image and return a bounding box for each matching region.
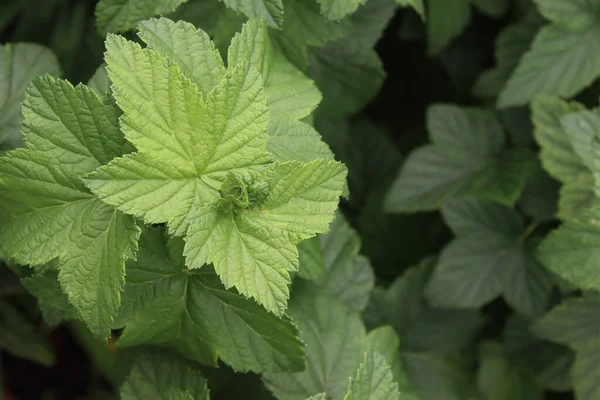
[0,43,60,147]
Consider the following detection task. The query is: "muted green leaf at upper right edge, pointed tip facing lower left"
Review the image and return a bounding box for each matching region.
[498,23,600,107]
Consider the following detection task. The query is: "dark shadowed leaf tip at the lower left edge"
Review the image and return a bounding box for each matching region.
[0,300,54,367]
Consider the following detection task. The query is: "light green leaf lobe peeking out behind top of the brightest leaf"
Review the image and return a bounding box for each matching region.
[138,18,225,98]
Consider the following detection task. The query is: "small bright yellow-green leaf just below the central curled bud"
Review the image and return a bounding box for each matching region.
[185,159,346,315]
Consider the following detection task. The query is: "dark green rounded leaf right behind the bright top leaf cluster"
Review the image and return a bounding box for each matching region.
[309,39,386,118]
